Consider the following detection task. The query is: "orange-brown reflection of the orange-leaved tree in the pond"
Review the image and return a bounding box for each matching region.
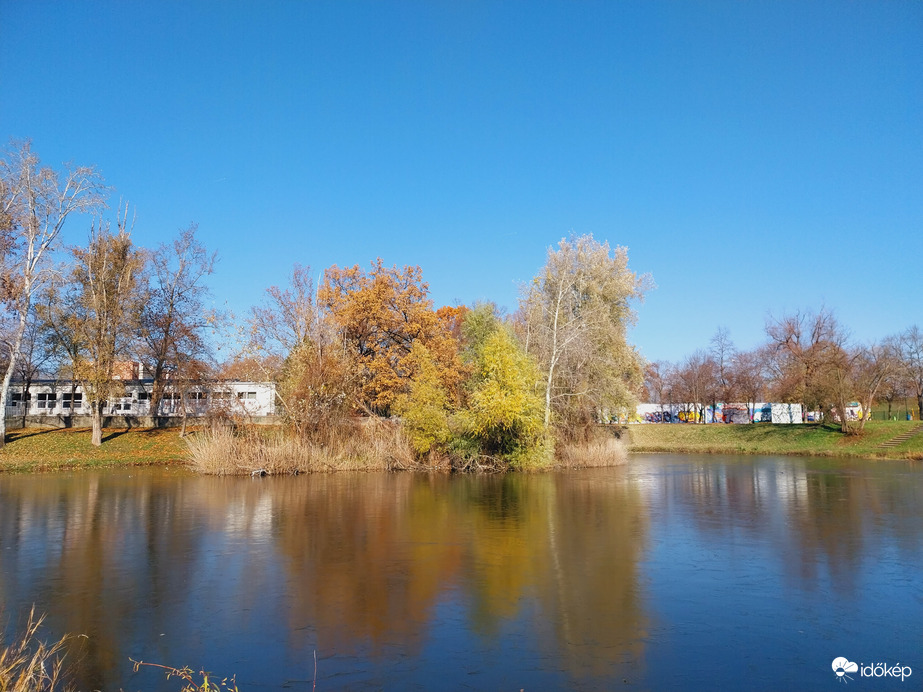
[273,474,460,653]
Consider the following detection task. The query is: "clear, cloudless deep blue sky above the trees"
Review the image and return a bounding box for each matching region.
[0,0,923,360]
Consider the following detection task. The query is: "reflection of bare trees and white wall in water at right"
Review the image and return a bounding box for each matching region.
[663,458,921,593]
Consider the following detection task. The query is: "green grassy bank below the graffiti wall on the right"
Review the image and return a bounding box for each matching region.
[628,421,923,459]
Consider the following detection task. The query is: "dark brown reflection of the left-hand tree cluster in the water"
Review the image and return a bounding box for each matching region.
[0,473,208,689]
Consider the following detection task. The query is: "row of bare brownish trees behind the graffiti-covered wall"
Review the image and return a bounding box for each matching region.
[643,316,923,433]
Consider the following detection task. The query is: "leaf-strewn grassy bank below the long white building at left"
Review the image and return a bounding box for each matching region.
[0,428,189,471]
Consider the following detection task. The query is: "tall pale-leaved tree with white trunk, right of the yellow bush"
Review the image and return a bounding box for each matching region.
[519,235,651,430]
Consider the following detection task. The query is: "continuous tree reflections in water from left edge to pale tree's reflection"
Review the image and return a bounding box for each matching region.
[0,470,646,689]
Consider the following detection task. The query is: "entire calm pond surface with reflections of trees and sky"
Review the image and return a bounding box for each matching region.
[0,455,923,691]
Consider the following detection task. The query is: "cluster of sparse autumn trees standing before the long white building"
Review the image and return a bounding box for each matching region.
[0,142,219,446]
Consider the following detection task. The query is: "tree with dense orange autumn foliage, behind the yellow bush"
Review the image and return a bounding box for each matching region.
[317,258,463,414]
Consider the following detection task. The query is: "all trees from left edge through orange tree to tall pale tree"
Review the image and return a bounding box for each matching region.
[0,142,649,467]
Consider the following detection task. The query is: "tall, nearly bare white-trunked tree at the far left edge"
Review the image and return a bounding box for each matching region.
[0,142,105,447]
